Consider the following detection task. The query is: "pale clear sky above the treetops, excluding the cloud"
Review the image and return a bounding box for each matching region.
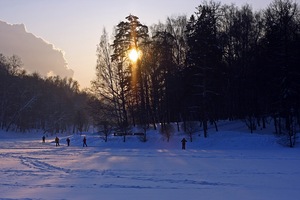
[0,0,292,88]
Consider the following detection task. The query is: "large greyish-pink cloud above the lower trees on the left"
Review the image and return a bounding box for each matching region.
[0,21,74,78]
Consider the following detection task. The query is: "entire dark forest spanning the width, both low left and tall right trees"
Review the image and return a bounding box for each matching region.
[0,0,300,146]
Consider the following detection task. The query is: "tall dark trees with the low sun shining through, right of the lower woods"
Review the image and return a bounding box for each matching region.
[92,0,300,145]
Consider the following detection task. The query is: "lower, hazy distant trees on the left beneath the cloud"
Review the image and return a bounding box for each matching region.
[0,54,90,134]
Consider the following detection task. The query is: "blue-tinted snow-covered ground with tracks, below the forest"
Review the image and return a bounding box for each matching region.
[0,122,300,200]
